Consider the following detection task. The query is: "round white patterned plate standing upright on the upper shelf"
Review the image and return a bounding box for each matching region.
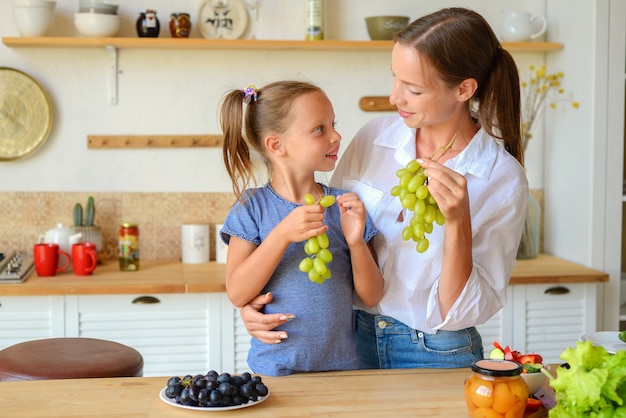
[198,0,249,39]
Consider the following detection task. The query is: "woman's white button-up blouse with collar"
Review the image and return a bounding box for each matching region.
[330,115,528,333]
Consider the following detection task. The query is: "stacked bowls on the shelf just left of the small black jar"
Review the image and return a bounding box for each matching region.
[74,0,122,37]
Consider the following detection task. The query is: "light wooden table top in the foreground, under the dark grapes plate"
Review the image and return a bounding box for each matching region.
[0,369,546,418]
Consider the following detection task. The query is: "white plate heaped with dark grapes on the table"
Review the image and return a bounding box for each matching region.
[159,370,270,412]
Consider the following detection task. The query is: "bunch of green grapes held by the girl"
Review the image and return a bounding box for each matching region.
[299,194,335,284]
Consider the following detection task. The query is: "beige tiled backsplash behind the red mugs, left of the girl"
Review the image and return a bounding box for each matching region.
[0,192,234,260]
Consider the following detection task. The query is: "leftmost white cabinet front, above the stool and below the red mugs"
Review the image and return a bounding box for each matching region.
[0,296,65,350]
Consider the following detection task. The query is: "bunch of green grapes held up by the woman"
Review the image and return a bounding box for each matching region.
[391,160,445,253]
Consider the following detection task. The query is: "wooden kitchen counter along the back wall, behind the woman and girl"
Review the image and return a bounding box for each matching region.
[0,254,609,296]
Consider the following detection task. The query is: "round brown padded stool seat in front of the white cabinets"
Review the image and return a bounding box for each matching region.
[0,338,143,381]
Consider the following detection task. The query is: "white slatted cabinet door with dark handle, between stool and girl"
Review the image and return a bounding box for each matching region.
[65,293,222,376]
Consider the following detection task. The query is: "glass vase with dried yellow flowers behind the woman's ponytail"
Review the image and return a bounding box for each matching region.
[517,65,579,260]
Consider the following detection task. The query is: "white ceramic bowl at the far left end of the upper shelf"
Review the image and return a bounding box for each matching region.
[13,0,56,36]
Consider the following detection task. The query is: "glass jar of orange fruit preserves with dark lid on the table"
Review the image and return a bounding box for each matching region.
[465,360,528,418]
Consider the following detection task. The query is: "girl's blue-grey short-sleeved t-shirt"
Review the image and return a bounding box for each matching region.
[221,185,378,376]
